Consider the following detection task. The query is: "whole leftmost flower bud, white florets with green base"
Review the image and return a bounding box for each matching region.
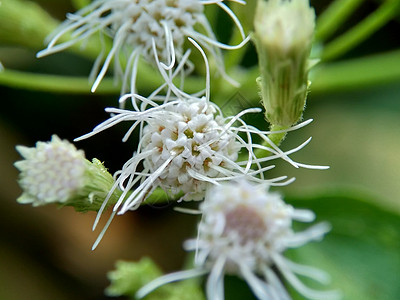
[14,135,120,212]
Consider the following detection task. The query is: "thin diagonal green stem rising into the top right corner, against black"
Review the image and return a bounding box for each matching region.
[322,0,400,61]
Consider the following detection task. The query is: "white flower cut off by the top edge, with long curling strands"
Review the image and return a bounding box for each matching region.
[37,0,248,93]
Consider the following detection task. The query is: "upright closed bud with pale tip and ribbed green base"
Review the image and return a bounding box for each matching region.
[253,0,315,129]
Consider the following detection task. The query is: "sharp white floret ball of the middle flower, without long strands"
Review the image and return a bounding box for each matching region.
[142,98,241,200]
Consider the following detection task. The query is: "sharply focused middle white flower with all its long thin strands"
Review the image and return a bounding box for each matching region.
[75,39,326,248]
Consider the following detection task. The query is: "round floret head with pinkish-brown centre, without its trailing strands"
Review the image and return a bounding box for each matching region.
[195,181,294,273]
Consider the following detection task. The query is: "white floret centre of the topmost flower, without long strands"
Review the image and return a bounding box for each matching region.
[108,0,204,61]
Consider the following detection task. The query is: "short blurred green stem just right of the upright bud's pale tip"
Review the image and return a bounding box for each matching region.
[315,0,364,42]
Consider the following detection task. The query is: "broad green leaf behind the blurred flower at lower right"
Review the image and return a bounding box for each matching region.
[288,194,400,300]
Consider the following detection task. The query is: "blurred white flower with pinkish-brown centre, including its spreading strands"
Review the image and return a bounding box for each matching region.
[136,180,338,300]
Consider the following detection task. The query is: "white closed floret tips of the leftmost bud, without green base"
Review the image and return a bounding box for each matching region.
[15,135,87,206]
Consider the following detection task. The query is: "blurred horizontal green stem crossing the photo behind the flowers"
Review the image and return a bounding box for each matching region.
[0,50,400,97]
